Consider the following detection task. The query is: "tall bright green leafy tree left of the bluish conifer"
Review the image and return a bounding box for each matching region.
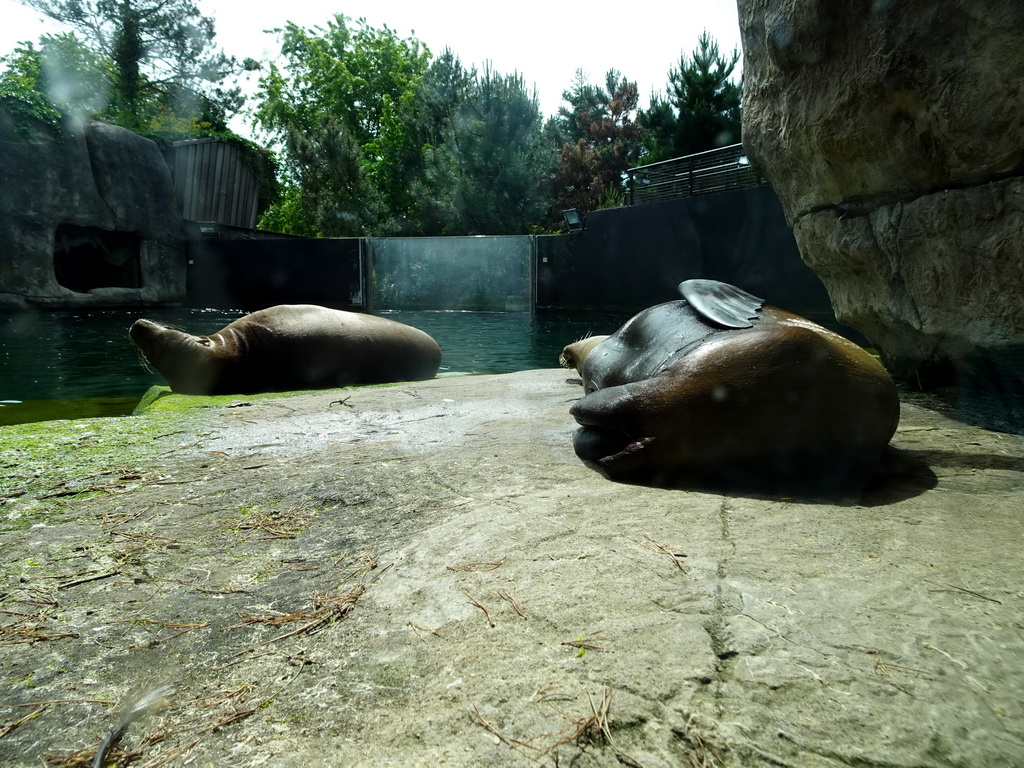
[255,14,430,237]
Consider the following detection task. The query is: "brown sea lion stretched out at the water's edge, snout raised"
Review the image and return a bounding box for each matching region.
[129,304,441,394]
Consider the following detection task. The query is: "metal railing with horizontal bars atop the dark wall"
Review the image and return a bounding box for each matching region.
[626,144,768,206]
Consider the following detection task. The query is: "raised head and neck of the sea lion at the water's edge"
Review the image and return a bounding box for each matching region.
[128,319,229,394]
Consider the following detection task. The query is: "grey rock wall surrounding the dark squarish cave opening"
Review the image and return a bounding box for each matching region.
[0,109,185,308]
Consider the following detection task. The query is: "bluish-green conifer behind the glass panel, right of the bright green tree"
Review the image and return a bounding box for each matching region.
[423,67,550,234]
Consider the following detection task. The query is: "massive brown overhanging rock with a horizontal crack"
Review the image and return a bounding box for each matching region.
[738,0,1024,423]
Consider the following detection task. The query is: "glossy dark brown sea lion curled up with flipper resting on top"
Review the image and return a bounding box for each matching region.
[562,280,899,495]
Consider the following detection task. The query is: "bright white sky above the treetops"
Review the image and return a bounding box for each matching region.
[0,0,739,133]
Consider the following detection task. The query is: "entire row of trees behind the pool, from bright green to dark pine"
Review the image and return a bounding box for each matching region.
[249,26,739,236]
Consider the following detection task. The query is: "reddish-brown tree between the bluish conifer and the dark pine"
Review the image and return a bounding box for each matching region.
[548,70,643,222]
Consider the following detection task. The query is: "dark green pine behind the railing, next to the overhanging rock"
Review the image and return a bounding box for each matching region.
[640,32,742,163]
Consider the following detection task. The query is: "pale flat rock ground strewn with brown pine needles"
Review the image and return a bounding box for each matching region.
[0,370,1024,768]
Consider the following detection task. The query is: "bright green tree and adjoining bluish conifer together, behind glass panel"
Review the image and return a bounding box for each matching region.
[255,15,548,237]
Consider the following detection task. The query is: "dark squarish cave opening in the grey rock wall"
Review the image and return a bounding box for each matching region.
[53,224,142,293]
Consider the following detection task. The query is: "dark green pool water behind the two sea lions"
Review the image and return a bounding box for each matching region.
[0,308,628,424]
